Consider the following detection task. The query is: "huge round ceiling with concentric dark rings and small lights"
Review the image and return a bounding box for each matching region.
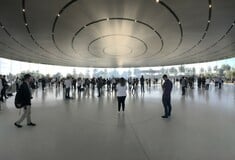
[0,0,235,67]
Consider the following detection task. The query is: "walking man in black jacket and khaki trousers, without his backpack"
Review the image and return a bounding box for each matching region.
[15,74,36,128]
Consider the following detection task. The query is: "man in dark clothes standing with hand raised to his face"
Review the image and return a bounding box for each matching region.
[162,74,172,118]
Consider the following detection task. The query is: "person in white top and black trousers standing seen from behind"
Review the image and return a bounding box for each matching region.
[116,77,127,112]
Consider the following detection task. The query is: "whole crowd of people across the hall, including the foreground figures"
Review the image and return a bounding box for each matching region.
[0,74,227,128]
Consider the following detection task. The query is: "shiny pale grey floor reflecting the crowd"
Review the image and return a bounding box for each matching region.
[0,84,235,160]
